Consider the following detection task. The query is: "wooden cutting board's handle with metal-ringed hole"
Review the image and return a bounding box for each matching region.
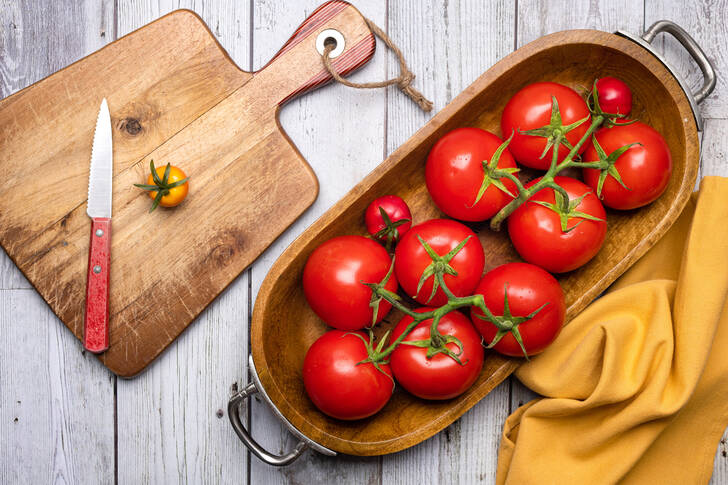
[255,0,376,105]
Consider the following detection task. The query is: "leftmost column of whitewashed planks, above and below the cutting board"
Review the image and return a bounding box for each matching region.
[0,0,115,484]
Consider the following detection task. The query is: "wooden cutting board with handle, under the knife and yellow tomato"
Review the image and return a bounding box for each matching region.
[0,0,375,377]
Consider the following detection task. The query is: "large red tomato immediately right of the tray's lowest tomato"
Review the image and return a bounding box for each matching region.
[389,308,484,400]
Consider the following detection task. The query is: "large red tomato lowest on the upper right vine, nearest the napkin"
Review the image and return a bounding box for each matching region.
[508,176,607,273]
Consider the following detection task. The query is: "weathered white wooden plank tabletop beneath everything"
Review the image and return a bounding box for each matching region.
[0,0,728,485]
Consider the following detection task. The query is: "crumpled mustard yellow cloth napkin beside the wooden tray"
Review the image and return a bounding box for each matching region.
[496,177,728,485]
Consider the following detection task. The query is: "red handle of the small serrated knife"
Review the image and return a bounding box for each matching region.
[83,217,111,354]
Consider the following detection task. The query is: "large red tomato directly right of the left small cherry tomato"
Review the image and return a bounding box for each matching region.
[394,219,485,306]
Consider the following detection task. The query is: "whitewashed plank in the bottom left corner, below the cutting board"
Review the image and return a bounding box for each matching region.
[0,289,115,484]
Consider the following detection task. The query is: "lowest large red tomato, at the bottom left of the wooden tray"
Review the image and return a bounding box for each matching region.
[303,330,394,420]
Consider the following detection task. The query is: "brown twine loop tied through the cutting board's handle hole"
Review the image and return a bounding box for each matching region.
[321,17,432,111]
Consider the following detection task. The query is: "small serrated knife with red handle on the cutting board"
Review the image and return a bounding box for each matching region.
[83,98,113,354]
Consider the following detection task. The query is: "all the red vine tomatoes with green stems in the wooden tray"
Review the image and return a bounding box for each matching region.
[303,78,672,420]
